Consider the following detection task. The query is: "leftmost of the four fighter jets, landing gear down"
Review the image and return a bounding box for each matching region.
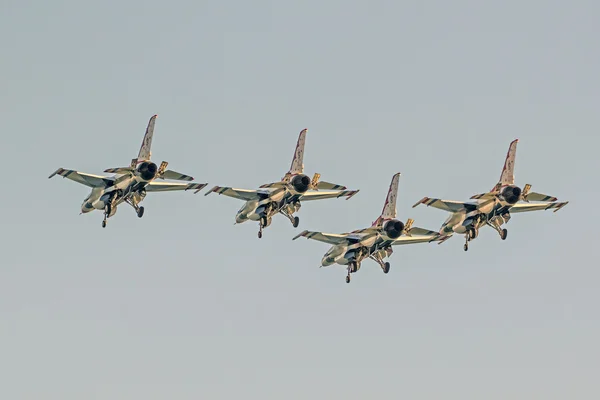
[48,115,207,228]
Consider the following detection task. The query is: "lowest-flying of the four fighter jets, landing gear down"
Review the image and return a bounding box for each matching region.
[292,173,440,283]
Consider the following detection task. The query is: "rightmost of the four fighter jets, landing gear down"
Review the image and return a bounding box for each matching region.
[413,139,568,251]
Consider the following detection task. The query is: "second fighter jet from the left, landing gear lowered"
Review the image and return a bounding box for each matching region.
[204,129,358,238]
